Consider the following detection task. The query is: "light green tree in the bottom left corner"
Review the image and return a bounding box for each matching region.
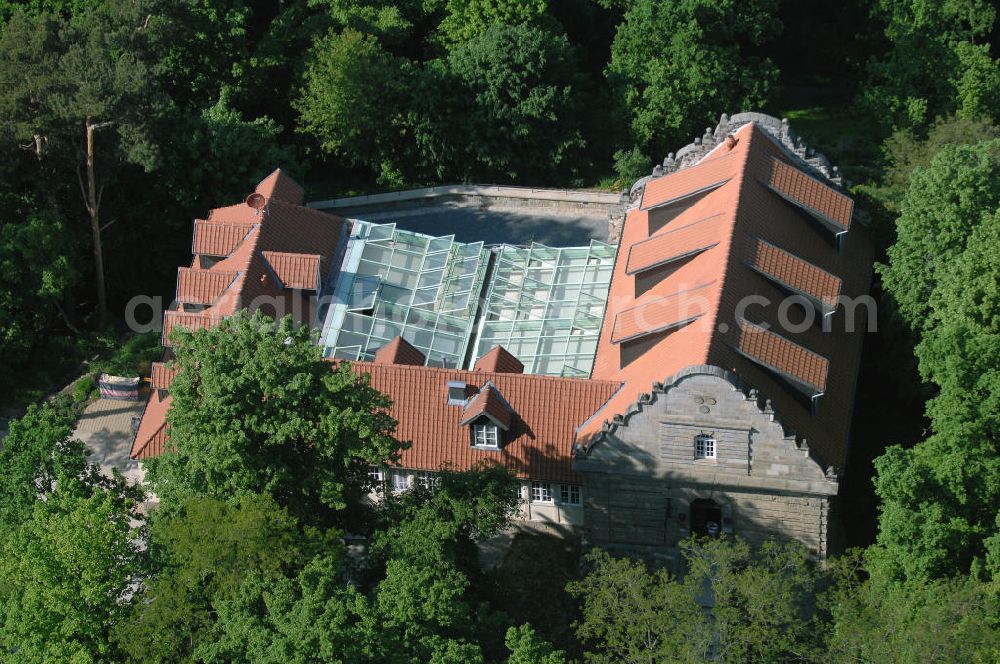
[0,490,141,662]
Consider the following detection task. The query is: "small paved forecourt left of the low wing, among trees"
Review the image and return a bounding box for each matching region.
[73,399,146,482]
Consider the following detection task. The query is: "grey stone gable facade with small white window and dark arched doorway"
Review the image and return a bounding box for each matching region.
[574,366,838,559]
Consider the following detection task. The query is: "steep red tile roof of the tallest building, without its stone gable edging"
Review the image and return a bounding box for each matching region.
[577,123,872,466]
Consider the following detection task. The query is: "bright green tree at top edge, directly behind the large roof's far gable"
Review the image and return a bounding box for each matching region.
[607,0,781,156]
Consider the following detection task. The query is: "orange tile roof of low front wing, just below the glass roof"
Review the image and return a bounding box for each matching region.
[348,362,619,484]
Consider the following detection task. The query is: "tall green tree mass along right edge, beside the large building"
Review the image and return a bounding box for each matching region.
[870,208,1000,579]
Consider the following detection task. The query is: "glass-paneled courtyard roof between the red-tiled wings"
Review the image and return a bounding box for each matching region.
[322,220,616,377]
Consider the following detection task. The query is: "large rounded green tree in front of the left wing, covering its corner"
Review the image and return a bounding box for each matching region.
[147,312,399,525]
